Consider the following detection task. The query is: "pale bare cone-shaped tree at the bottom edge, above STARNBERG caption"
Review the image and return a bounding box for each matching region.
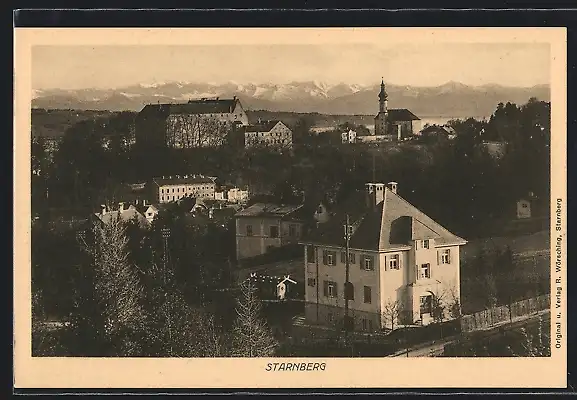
[232,279,278,357]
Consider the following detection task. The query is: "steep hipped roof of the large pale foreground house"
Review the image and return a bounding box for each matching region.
[302,187,466,251]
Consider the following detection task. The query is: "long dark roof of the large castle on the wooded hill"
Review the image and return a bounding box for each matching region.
[140,98,240,117]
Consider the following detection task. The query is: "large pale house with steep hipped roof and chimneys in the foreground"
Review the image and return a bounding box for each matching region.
[300,182,466,331]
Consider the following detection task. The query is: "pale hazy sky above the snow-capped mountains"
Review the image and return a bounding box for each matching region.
[32,43,550,89]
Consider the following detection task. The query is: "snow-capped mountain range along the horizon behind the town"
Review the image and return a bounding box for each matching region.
[32,81,550,116]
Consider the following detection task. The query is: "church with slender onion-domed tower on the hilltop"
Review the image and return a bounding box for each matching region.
[375,80,420,141]
